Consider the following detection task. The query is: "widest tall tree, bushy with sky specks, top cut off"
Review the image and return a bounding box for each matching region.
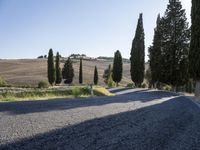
[160,0,190,88]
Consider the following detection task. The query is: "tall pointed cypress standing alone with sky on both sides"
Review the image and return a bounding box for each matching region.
[130,14,145,86]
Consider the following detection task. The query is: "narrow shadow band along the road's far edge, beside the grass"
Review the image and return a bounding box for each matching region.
[0,91,177,114]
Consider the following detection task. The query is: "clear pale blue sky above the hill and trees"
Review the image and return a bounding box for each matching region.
[0,0,191,61]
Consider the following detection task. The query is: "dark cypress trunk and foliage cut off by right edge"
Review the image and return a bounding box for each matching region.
[189,0,200,97]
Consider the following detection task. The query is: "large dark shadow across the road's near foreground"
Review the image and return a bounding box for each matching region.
[0,97,200,150]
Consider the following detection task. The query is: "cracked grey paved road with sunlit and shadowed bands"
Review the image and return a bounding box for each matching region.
[0,90,200,150]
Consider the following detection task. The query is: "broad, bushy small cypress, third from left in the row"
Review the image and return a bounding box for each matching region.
[62,58,74,84]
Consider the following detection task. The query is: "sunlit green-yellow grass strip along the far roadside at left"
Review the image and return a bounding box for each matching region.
[0,86,113,101]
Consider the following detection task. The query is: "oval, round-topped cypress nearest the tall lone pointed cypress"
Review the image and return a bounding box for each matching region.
[112,50,123,86]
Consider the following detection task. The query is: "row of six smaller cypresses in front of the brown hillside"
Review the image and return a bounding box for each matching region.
[48,49,123,85]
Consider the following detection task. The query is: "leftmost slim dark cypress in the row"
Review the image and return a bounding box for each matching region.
[47,49,56,85]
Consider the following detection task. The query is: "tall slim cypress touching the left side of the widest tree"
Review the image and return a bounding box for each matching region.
[149,14,162,88]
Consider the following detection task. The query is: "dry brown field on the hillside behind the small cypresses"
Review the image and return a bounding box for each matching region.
[0,59,134,86]
